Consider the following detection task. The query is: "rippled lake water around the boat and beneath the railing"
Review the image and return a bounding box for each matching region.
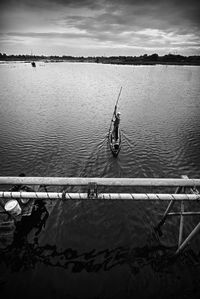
[0,62,200,299]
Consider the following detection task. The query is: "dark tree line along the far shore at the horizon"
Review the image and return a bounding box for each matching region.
[0,53,200,65]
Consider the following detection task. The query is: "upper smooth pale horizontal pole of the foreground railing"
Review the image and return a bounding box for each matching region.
[0,177,200,187]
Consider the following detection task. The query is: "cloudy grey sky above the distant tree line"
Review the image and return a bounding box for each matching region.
[0,0,200,57]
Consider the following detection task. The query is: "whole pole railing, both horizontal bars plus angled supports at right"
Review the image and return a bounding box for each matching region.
[0,176,200,254]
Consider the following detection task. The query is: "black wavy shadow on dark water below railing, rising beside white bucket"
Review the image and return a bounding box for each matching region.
[0,200,200,274]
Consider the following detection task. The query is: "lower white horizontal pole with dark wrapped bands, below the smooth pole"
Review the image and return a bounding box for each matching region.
[0,191,200,201]
